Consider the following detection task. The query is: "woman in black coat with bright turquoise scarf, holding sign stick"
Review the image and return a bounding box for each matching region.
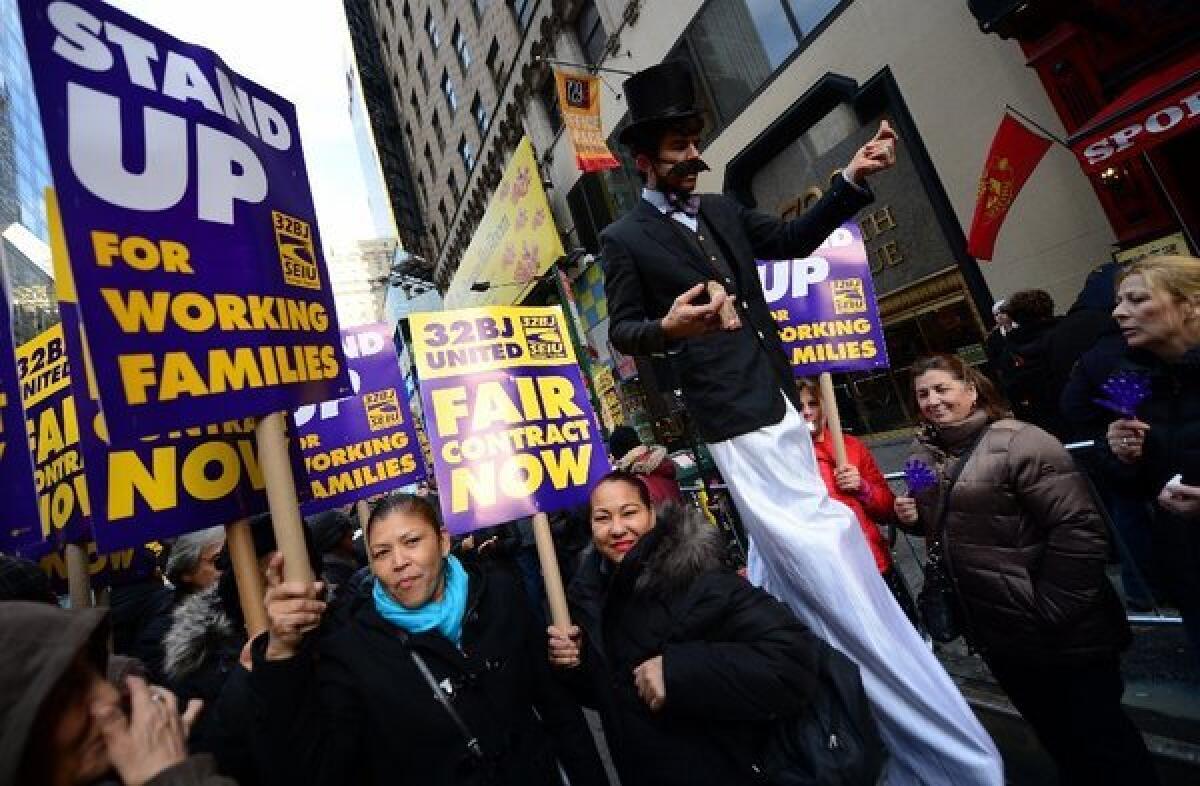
[251,494,607,786]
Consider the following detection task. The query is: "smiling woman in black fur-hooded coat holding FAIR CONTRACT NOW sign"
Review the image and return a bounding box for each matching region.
[550,472,816,786]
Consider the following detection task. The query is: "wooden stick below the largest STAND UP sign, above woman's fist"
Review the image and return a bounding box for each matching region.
[254,412,313,582]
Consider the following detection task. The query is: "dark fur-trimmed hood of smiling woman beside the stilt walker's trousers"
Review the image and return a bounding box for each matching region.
[622,504,726,594]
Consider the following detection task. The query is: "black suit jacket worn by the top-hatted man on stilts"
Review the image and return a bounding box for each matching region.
[600,176,871,442]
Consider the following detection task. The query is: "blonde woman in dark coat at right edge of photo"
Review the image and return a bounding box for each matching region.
[1103,257,1200,658]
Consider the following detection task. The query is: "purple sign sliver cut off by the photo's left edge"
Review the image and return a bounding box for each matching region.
[0,273,43,554]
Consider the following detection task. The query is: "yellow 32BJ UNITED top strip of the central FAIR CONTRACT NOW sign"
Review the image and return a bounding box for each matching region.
[409,306,576,382]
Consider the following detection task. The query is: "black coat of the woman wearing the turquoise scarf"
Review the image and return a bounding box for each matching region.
[251,565,607,786]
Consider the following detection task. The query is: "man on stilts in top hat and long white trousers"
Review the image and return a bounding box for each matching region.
[601,62,1003,786]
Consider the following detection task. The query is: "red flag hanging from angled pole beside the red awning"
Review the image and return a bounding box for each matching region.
[967,112,1051,259]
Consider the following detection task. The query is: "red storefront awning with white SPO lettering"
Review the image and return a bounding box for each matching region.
[1069,54,1200,174]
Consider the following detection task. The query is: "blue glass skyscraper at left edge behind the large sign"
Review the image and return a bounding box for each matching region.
[0,0,58,343]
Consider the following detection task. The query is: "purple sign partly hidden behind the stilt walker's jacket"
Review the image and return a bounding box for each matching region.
[758,221,888,377]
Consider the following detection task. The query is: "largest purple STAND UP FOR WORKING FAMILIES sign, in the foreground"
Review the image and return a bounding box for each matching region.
[19,0,350,438]
